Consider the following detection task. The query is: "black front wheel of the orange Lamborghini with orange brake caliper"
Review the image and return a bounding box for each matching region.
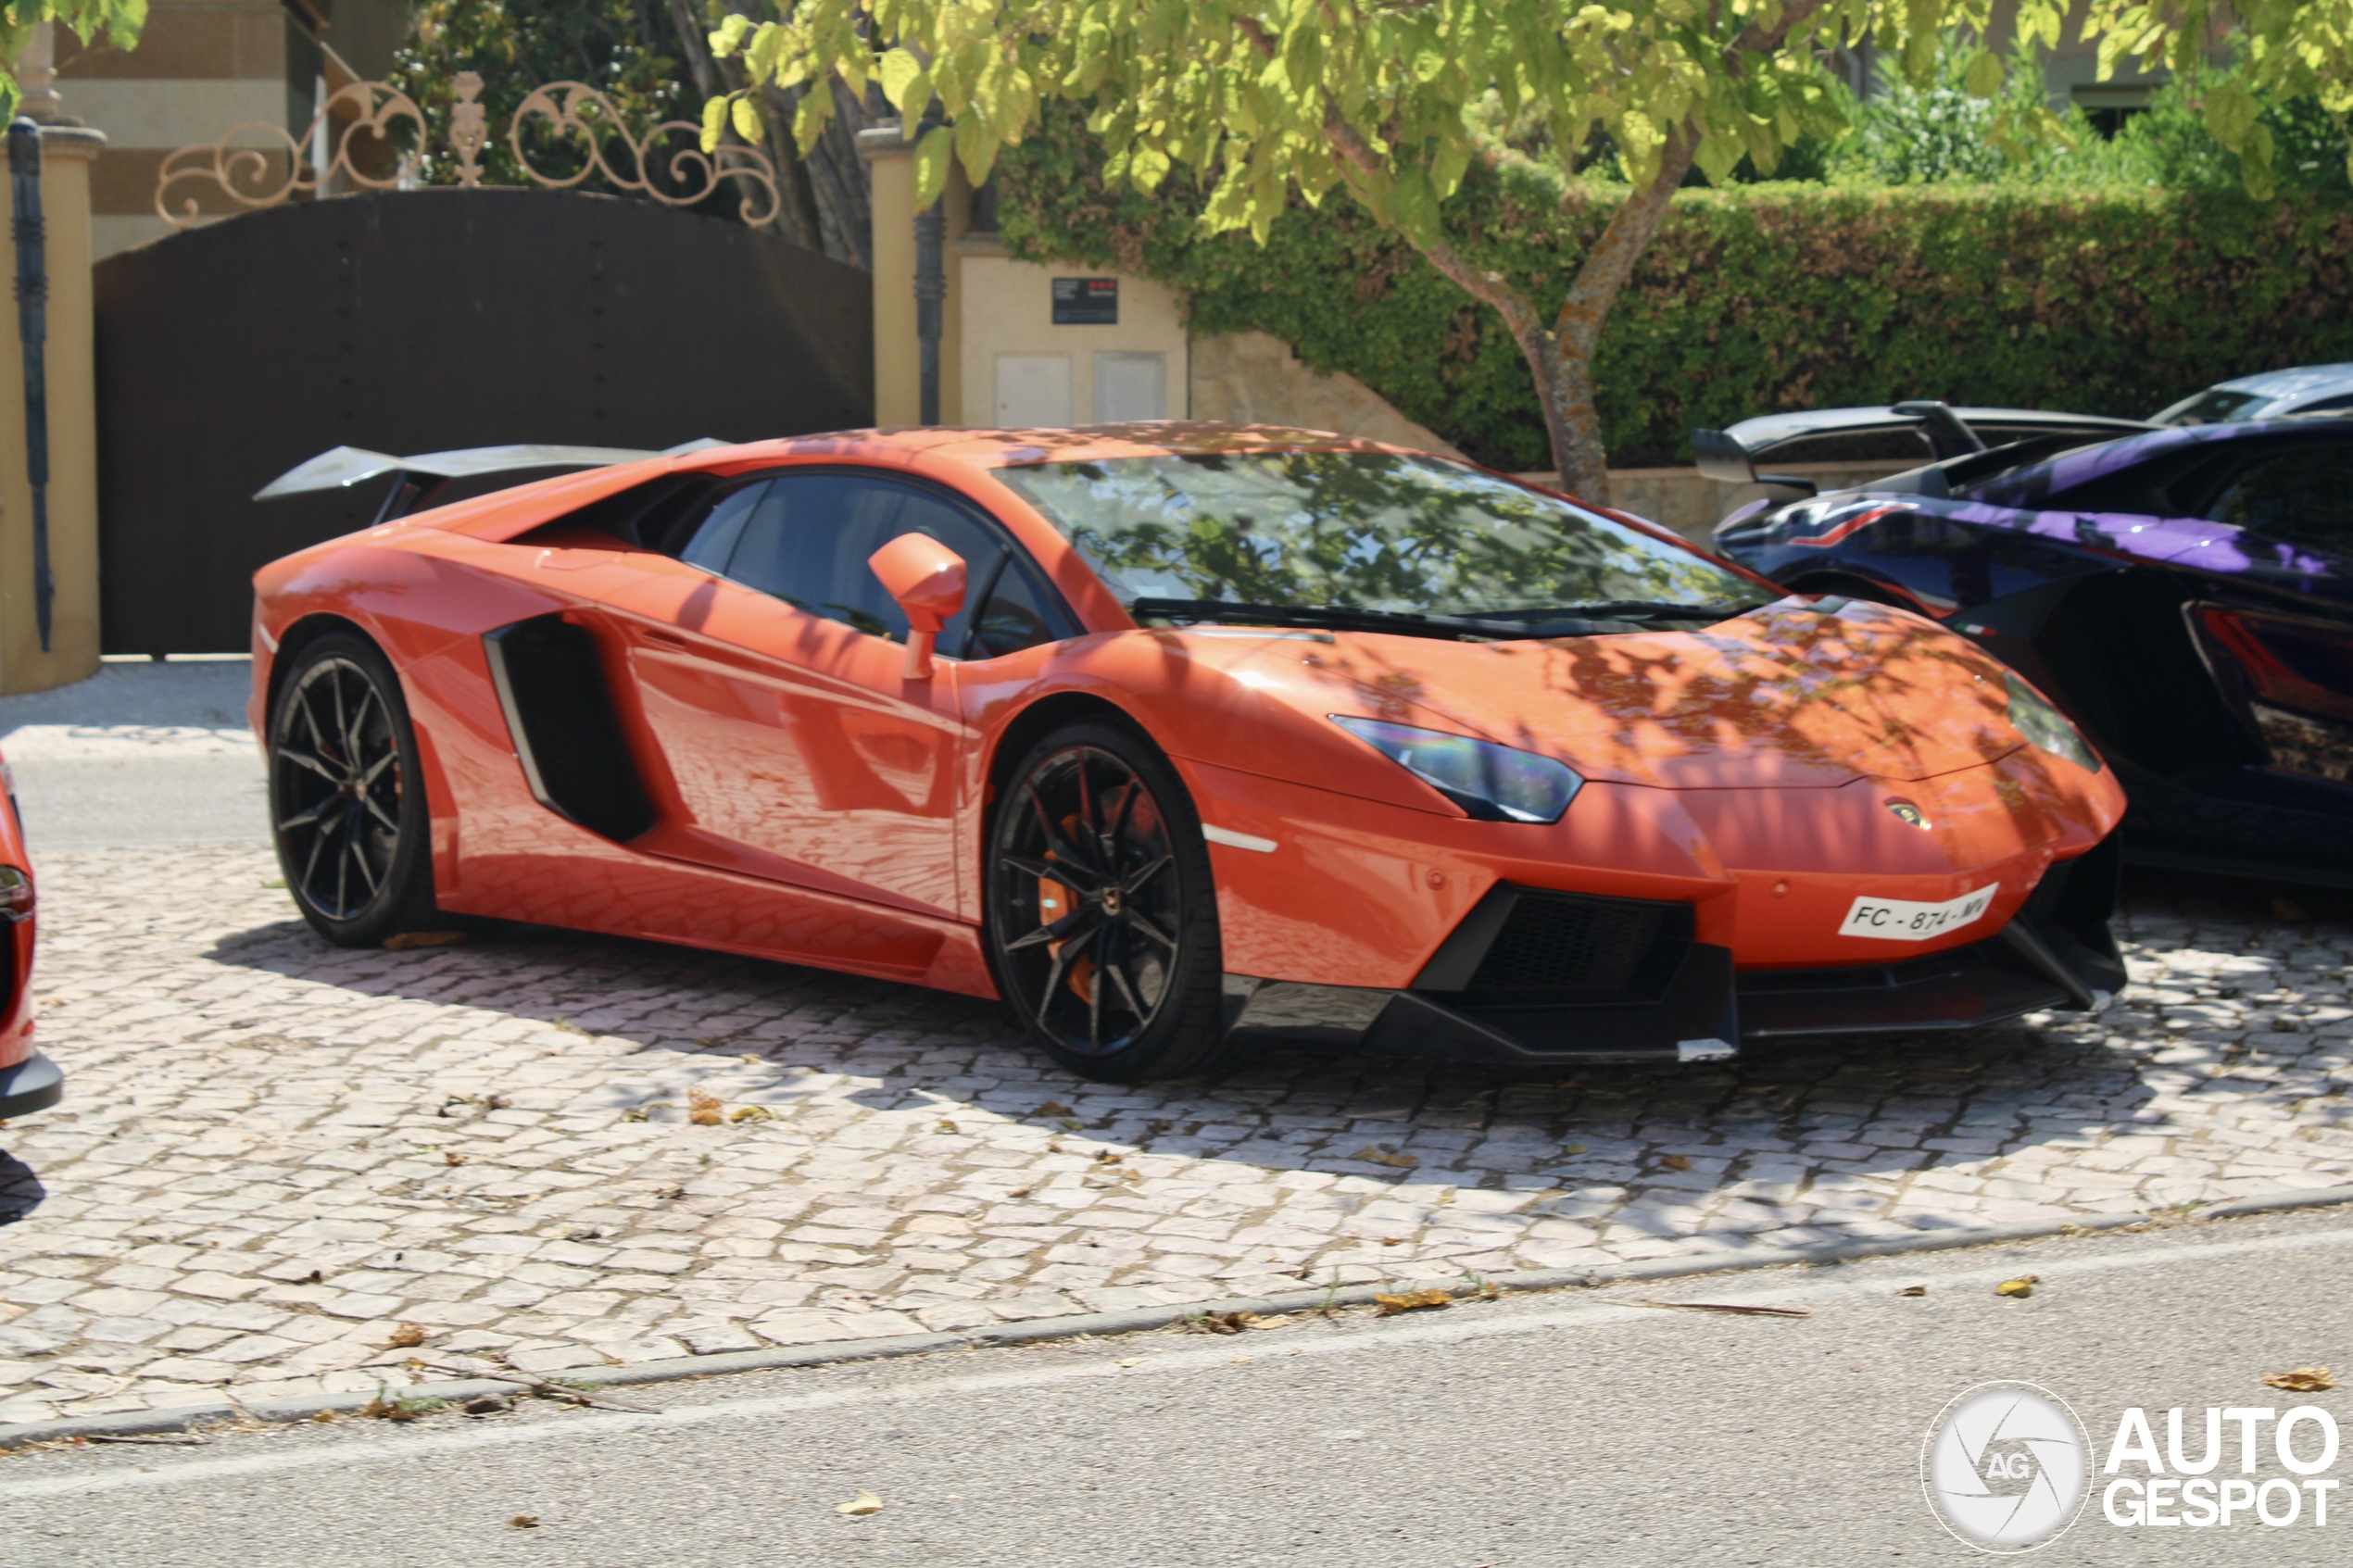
[988,724,1224,1084]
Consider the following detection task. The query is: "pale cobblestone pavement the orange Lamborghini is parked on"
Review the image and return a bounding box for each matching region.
[0,847,2353,1423]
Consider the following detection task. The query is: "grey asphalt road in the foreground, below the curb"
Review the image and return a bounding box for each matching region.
[0,1210,2353,1568]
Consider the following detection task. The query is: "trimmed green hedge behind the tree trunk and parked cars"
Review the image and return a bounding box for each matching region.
[998,125,2353,470]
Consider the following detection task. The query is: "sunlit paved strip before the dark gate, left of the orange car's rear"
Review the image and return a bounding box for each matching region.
[0,659,266,870]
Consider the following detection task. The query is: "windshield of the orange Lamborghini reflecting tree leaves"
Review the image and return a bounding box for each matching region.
[995,451,1772,621]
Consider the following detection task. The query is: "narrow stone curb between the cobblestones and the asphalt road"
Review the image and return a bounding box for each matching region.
[0,1185,2353,1449]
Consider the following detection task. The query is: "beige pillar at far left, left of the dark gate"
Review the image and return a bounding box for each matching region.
[0,120,106,694]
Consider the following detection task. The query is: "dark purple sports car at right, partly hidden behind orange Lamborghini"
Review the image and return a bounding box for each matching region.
[1696,405,2353,886]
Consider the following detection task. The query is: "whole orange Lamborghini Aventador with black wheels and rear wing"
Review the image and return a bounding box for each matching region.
[252,425,2125,1082]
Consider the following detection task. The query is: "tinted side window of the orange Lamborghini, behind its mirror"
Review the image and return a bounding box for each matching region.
[715,472,1005,649]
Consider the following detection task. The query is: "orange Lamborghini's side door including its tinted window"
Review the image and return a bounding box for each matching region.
[616,468,1010,914]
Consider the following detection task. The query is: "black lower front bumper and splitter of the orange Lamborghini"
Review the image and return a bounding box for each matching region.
[1226,837,2125,1067]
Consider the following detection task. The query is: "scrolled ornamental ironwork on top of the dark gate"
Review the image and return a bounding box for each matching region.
[156,70,781,228]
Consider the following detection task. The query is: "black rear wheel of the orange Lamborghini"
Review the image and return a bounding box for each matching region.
[271,634,433,947]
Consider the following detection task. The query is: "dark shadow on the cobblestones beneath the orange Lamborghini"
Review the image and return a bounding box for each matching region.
[209,893,2153,1198]
